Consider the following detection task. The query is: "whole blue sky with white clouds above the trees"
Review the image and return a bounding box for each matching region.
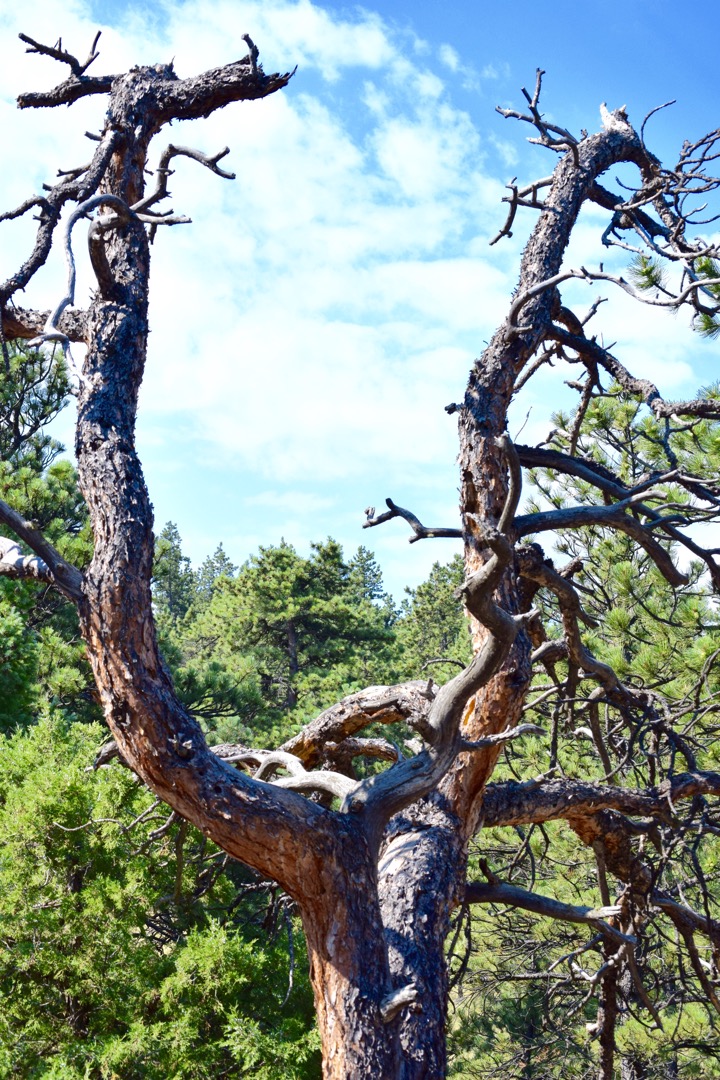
[0,0,720,596]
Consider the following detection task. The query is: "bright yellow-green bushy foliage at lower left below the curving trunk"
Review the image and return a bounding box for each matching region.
[0,716,318,1080]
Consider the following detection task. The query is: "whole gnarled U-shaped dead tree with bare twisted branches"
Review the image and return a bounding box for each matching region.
[0,38,720,1080]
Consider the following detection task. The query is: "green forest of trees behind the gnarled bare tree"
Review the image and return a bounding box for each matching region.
[0,343,720,1080]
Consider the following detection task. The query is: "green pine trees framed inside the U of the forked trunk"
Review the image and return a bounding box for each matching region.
[148,522,471,745]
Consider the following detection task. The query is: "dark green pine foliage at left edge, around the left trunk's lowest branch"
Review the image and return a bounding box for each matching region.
[0,349,99,731]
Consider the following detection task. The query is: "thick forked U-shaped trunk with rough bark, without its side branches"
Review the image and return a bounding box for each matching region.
[2,38,686,1080]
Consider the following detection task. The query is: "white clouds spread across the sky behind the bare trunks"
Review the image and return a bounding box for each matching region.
[0,0,708,580]
